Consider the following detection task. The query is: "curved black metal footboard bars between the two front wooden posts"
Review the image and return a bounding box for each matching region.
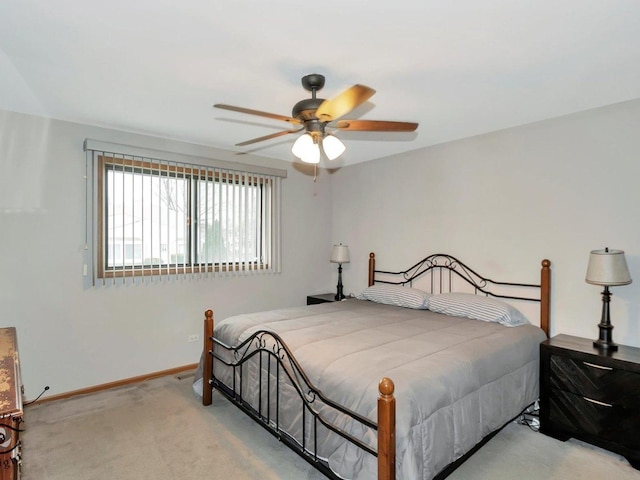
[209,330,378,479]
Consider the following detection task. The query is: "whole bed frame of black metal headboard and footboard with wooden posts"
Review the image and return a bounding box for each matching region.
[202,253,551,480]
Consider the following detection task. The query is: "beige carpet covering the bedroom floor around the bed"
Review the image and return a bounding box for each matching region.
[22,376,640,480]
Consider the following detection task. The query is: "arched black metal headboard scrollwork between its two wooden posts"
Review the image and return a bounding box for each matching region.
[369,253,544,302]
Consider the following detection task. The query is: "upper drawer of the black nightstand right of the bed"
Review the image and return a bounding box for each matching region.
[549,355,640,408]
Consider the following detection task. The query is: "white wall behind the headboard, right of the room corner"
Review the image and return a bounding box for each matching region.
[333,100,640,346]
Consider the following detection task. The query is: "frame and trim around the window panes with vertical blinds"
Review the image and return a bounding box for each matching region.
[83,139,287,285]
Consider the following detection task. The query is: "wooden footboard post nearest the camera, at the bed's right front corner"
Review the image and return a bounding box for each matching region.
[378,376,396,480]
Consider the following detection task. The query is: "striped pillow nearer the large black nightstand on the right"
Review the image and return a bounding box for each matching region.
[429,293,529,327]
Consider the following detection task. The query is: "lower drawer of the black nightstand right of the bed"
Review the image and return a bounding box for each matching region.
[549,389,640,450]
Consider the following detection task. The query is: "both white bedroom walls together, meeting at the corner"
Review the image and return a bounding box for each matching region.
[5,101,640,398]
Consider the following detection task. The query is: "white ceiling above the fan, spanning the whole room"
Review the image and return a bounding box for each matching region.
[0,0,640,166]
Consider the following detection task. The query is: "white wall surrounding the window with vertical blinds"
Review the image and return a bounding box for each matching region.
[0,111,335,399]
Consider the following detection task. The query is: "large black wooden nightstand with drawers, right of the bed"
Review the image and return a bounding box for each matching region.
[540,335,640,470]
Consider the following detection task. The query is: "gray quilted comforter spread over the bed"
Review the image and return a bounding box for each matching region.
[199,300,545,480]
